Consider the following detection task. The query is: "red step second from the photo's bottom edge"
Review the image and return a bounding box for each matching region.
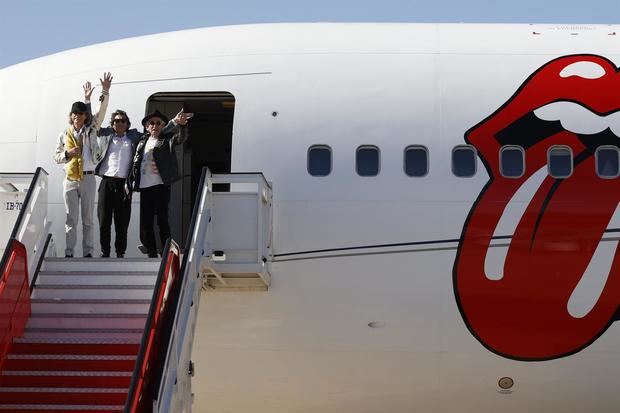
[0,387,127,406]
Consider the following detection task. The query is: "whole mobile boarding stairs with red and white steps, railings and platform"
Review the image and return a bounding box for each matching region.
[0,168,272,413]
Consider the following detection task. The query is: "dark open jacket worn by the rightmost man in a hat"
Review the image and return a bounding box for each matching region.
[131,125,187,192]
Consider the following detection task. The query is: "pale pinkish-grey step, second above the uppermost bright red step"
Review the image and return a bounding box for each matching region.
[26,314,146,329]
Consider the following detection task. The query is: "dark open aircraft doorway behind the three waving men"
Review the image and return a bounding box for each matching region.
[146,92,235,248]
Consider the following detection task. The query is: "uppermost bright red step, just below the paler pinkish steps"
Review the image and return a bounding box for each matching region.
[11,342,140,356]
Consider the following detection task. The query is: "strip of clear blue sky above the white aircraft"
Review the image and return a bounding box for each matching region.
[0,0,620,67]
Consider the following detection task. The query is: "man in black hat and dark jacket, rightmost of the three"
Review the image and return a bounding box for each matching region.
[131,110,193,258]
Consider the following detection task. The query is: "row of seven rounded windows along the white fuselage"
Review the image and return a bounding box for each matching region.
[308,145,620,179]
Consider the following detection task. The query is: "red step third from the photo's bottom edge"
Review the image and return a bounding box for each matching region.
[0,371,132,389]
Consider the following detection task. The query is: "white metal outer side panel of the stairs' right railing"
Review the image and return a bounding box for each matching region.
[153,167,213,413]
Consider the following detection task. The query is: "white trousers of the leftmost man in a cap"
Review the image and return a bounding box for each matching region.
[62,174,97,256]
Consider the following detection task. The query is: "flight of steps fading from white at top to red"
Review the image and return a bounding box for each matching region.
[0,258,160,413]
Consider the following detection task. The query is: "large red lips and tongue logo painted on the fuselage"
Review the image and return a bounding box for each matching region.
[453,55,620,360]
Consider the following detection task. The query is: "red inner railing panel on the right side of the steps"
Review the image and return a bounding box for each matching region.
[124,238,180,413]
